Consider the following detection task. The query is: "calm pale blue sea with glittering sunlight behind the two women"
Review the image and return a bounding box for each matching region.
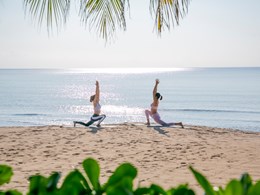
[0,68,260,131]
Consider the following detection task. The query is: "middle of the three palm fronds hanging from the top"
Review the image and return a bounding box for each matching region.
[80,0,129,40]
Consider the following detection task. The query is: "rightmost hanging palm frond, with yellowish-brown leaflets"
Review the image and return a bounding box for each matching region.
[150,0,190,35]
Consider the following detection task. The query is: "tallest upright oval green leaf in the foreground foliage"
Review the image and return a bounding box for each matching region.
[83,158,100,191]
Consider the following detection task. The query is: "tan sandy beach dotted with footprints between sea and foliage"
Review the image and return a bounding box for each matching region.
[0,123,260,194]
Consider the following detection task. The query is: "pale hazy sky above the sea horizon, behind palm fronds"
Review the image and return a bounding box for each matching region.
[0,0,260,68]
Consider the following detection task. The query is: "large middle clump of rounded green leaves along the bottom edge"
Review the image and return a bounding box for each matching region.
[25,158,194,195]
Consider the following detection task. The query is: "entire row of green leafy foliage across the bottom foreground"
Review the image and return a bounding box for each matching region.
[0,158,260,195]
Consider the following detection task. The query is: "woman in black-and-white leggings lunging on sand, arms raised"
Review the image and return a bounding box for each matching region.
[73,81,106,127]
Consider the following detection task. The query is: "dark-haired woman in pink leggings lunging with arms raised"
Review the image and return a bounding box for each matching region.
[145,79,184,128]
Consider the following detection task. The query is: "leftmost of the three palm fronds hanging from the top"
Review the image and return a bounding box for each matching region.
[24,0,70,31]
